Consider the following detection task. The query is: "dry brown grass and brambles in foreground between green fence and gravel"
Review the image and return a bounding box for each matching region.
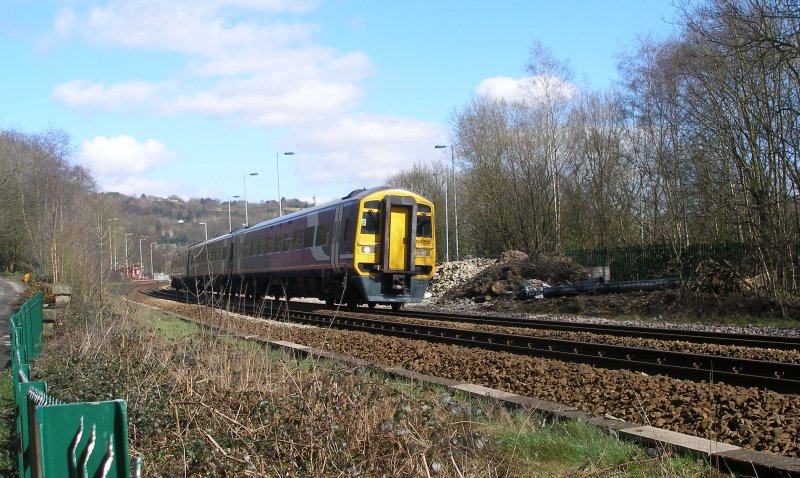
[20,300,732,478]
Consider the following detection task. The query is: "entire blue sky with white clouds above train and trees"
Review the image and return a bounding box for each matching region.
[0,0,677,202]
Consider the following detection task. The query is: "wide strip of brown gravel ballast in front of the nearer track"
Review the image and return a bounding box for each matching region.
[136,295,800,458]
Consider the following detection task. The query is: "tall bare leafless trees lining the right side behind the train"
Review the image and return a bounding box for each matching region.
[389,0,800,296]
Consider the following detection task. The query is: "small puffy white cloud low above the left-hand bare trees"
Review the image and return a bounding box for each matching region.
[78,135,177,177]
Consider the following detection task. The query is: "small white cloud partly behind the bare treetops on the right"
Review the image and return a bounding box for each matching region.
[476,75,580,104]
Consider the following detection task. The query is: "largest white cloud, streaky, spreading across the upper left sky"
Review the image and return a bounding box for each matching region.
[47,0,372,126]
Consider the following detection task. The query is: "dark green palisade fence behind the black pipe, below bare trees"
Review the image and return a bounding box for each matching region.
[565,242,755,281]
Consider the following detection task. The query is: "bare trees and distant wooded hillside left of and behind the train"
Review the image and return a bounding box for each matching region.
[0,130,310,301]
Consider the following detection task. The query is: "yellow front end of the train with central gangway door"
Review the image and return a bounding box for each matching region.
[352,190,436,309]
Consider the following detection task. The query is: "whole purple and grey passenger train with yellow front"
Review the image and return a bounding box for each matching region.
[166,187,436,310]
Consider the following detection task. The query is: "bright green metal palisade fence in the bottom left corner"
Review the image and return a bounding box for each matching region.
[9,292,141,478]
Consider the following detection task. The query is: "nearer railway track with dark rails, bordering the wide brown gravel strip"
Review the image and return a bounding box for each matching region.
[145,290,800,393]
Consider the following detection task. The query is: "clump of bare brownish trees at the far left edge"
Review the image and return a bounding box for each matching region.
[0,131,113,299]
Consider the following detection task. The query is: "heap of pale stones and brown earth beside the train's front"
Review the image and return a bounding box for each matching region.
[428,251,590,303]
